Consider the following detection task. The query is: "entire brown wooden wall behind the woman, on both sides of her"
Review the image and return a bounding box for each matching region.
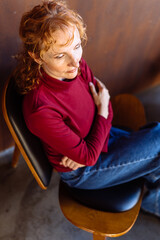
[0,0,160,151]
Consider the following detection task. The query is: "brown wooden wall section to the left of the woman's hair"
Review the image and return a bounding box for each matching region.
[0,0,41,151]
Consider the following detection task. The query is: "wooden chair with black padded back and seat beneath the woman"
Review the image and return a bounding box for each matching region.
[2,74,145,240]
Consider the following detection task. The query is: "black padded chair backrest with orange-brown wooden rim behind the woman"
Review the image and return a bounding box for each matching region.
[2,76,53,189]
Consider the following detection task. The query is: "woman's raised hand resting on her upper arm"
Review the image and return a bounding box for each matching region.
[89,79,110,118]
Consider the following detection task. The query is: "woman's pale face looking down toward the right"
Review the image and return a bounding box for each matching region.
[41,27,82,80]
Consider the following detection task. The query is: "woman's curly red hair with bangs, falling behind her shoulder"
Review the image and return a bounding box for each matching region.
[15,0,87,94]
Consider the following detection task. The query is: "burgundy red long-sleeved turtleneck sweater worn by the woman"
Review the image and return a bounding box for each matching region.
[23,59,113,172]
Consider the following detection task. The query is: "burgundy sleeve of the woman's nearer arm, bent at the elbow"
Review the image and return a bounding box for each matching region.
[26,107,112,166]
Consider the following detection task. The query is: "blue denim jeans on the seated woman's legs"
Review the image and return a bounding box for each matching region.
[60,122,160,217]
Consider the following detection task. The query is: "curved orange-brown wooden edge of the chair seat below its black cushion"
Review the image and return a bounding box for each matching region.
[59,182,141,239]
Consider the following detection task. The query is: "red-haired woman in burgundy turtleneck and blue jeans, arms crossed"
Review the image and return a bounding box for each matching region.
[15,0,160,216]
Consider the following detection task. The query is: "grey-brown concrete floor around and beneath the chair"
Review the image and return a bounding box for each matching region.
[0,87,160,240]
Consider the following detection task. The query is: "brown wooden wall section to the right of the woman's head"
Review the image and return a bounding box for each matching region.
[68,0,160,95]
